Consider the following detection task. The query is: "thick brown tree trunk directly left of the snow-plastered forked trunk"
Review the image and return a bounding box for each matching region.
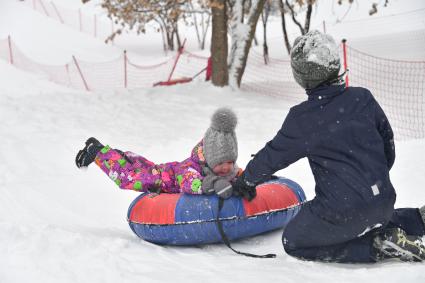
[211,0,229,86]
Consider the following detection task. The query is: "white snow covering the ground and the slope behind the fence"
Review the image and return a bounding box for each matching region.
[0,0,425,283]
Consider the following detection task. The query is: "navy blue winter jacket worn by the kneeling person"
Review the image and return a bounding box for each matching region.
[244,85,395,220]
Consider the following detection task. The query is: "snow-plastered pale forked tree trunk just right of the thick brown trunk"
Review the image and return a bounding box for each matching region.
[229,0,266,88]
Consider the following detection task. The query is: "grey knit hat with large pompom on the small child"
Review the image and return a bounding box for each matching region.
[204,107,238,169]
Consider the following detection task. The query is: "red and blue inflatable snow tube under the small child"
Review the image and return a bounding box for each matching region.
[127,178,306,245]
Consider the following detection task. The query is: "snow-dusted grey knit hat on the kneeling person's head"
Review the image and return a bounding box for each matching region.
[291,30,341,89]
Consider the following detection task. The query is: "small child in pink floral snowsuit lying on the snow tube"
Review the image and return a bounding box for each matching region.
[76,108,242,198]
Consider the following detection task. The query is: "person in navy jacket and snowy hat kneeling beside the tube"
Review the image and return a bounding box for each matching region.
[233,31,425,262]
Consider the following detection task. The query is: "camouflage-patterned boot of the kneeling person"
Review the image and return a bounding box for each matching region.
[373,228,425,261]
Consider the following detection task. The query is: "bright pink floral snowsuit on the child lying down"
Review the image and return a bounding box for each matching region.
[95,141,219,194]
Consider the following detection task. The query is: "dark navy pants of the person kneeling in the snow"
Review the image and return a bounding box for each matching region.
[282,202,425,263]
